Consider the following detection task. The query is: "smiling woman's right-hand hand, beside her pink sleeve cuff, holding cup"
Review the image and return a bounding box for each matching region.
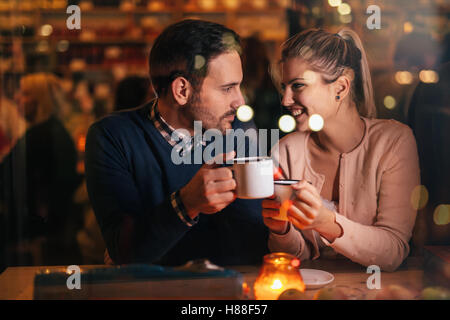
[288,180,334,231]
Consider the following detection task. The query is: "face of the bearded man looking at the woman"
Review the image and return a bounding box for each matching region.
[186,51,245,133]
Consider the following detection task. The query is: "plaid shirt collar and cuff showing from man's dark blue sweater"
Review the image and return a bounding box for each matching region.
[149,99,199,227]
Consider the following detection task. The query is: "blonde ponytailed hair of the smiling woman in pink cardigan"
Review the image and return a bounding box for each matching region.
[281,29,376,118]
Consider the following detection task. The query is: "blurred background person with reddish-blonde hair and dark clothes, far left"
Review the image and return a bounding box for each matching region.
[0,73,81,265]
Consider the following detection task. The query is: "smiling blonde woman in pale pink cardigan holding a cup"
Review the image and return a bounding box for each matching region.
[262,30,420,271]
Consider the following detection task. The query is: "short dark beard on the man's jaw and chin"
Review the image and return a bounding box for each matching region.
[183,93,235,134]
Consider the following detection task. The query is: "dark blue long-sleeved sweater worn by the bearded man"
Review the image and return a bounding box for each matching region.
[86,103,268,265]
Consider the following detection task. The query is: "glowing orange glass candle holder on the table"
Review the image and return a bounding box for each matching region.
[253,252,305,300]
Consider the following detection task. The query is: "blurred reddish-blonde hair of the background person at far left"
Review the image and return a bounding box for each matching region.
[20,72,67,124]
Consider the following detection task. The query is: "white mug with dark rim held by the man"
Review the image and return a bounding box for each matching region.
[233,157,274,199]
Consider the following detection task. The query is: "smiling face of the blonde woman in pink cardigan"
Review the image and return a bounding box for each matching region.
[281,58,337,131]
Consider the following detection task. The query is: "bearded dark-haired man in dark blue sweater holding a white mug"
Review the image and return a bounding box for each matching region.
[86,20,267,265]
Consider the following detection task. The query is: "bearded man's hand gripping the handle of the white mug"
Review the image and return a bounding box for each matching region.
[180,151,236,219]
